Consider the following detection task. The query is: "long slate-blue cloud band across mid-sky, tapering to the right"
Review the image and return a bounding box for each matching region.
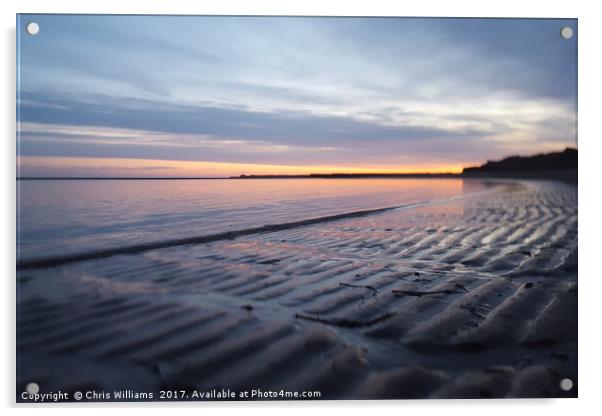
[19,94,487,147]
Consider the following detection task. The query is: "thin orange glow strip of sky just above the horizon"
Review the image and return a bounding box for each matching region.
[17,156,464,178]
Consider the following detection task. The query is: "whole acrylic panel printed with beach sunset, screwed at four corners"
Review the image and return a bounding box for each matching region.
[16,14,578,402]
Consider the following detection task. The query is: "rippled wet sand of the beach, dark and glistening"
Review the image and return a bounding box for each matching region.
[17,180,578,399]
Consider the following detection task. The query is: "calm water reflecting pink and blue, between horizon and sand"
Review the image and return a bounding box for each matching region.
[17,179,492,259]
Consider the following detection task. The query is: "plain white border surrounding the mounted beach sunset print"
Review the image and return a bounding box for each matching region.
[0,0,602,416]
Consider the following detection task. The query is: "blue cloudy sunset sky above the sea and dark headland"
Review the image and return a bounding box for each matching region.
[17,15,577,177]
